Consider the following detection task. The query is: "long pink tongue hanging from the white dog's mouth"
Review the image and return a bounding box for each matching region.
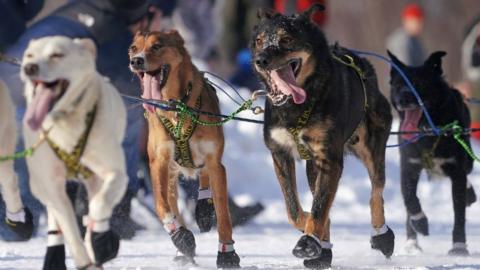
[23,83,55,131]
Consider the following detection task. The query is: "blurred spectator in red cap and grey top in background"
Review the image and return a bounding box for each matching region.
[387,4,425,66]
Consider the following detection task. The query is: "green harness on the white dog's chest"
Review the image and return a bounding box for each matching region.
[45,105,97,179]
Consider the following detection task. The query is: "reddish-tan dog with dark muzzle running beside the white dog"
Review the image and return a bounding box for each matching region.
[129,30,240,268]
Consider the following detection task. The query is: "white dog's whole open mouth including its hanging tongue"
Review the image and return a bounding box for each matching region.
[24,79,69,131]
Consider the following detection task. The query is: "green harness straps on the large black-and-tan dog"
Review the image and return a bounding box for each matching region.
[287,53,368,160]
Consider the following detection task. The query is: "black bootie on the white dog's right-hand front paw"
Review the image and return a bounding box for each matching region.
[91,230,120,265]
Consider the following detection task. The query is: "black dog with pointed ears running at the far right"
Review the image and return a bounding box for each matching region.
[389,52,476,255]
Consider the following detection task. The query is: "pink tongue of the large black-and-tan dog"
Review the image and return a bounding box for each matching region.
[270,65,307,104]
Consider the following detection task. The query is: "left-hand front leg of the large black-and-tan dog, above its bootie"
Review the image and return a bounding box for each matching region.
[272,149,307,231]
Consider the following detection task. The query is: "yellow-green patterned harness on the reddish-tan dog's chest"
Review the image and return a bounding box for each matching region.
[157,96,202,169]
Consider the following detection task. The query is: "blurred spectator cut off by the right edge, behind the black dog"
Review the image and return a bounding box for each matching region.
[462,18,480,140]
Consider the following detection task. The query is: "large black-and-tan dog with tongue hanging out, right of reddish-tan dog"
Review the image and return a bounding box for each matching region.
[251,5,394,268]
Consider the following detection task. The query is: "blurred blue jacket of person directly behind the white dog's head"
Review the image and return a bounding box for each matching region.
[0,1,139,106]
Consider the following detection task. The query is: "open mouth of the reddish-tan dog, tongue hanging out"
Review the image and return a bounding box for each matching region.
[137,65,170,112]
